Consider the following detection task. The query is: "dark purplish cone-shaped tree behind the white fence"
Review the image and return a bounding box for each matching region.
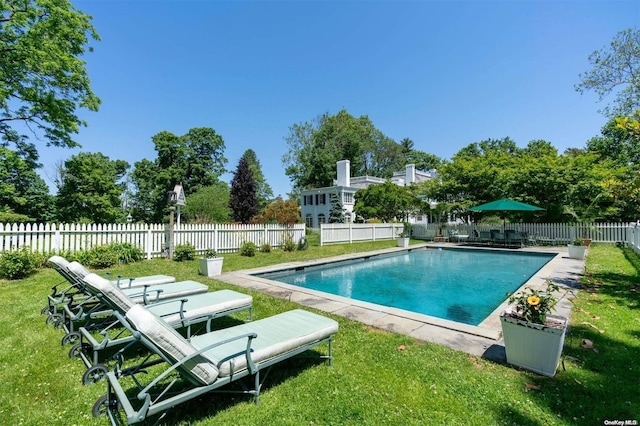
[229,158,258,223]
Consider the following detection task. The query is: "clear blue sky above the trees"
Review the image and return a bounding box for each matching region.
[39,0,640,196]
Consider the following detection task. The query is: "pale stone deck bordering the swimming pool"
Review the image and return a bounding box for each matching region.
[215,243,584,362]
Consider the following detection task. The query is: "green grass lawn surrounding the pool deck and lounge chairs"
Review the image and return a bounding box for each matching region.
[0,242,640,426]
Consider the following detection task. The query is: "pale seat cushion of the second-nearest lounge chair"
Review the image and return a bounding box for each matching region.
[147,290,253,325]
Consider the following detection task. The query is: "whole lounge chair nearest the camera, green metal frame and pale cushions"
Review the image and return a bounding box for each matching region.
[93,305,338,425]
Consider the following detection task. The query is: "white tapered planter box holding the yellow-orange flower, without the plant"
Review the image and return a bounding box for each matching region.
[500,312,568,377]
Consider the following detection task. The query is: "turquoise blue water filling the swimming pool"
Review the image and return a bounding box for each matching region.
[259,249,554,325]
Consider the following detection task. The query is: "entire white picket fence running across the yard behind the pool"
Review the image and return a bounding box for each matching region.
[0,223,640,259]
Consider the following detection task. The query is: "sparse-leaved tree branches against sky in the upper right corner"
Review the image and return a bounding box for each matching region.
[575,28,640,118]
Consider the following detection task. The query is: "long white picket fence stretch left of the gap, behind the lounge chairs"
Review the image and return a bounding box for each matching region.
[0,223,305,259]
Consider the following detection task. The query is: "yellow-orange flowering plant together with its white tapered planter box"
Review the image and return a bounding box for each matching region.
[500,280,568,377]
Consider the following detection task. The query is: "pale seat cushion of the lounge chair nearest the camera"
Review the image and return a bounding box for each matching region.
[191,309,338,377]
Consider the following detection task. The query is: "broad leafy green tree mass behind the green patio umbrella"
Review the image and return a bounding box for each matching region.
[418,138,638,222]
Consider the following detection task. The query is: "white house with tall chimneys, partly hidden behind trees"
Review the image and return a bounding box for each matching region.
[300,160,436,228]
